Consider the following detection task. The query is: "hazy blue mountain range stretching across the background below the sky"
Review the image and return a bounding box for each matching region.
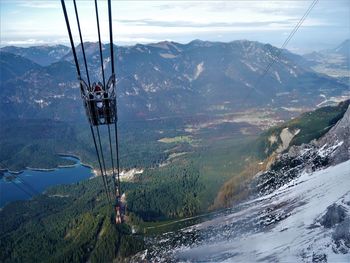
[0,40,347,119]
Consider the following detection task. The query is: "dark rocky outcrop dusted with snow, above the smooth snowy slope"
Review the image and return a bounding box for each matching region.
[251,106,350,195]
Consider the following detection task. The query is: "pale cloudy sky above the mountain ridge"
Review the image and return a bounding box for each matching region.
[0,0,350,53]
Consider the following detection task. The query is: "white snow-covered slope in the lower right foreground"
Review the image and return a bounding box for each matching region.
[147,161,350,262]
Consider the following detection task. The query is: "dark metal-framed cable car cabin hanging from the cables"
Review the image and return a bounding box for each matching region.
[82,77,116,126]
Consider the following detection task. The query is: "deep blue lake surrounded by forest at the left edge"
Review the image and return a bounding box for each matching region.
[0,157,94,207]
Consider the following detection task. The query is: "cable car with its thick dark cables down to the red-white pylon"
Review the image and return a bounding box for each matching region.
[61,0,125,224]
